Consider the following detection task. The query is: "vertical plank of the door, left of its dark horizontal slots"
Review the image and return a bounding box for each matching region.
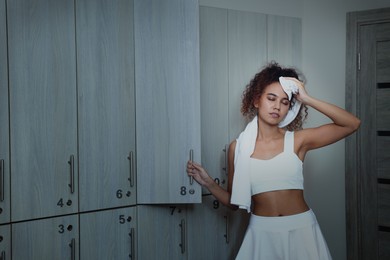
[358,25,378,259]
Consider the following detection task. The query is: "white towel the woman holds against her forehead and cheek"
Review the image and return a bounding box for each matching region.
[279,77,302,128]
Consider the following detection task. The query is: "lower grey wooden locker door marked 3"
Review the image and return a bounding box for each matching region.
[12,215,79,260]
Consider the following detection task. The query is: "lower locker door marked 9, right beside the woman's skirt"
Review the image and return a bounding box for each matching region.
[187,195,250,260]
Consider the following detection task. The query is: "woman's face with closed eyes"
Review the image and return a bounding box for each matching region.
[254,82,290,125]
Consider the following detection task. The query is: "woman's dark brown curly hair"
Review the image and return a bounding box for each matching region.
[241,61,308,131]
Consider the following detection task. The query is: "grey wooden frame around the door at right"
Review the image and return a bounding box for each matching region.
[345,8,390,260]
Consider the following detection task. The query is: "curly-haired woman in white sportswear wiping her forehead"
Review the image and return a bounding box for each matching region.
[187,63,360,260]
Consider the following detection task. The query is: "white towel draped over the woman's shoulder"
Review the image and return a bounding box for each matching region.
[230,116,258,212]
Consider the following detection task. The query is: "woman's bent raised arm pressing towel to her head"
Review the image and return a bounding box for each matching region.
[293,79,360,159]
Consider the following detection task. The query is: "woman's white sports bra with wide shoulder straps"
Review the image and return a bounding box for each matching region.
[249,131,303,195]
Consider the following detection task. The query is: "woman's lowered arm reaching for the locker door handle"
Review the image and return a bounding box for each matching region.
[187,141,238,209]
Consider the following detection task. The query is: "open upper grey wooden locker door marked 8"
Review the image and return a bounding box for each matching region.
[134,0,201,204]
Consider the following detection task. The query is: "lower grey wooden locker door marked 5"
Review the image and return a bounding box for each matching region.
[80,207,137,260]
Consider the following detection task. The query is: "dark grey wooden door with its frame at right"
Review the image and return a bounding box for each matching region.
[346,9,390,260]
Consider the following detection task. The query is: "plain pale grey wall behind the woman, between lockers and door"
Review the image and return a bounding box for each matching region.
[199,0,390,260]
